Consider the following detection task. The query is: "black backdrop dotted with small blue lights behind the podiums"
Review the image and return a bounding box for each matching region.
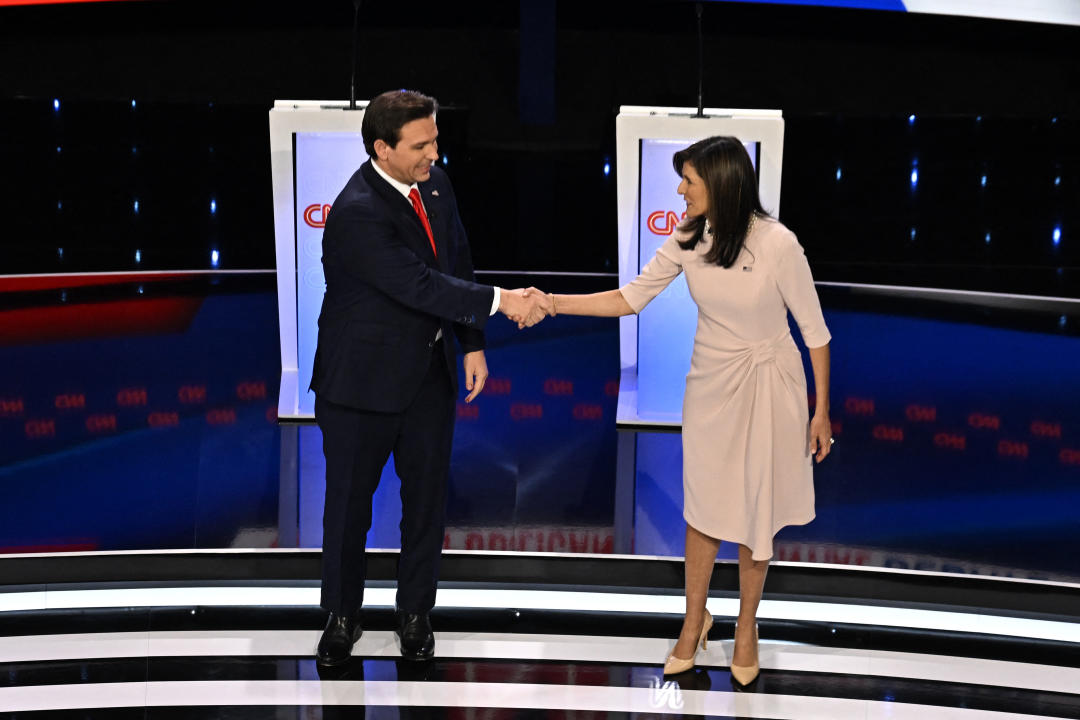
[0,0,1080,296]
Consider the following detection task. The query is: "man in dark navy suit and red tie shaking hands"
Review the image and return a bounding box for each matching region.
[311,91,551,665]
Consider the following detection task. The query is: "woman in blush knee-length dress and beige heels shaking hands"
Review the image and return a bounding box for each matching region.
[531,137,833,685]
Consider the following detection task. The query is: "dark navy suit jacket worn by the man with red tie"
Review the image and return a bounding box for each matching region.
[311,160,495,412]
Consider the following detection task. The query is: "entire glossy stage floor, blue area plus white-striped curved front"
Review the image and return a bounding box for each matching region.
[0,274,1080,718]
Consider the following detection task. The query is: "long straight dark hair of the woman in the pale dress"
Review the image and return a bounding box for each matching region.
[673,135,768,268]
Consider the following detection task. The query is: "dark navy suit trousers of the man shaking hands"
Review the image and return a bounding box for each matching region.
[315,340,457,614]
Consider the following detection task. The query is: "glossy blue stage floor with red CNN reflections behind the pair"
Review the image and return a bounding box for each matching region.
[0,275,1080,581]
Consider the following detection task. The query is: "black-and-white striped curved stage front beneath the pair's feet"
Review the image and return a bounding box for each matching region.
[0,585,1080,720]
